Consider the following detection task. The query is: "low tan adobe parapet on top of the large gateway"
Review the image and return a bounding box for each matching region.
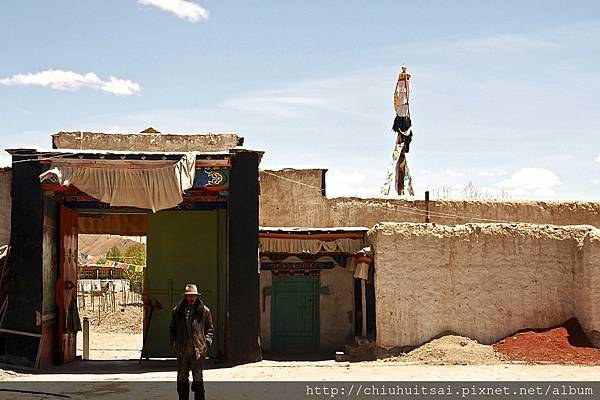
[52,132,244,152]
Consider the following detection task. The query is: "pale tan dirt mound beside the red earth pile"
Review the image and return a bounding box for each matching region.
[390,335,503,365]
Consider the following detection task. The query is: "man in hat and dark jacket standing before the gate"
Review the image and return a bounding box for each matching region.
[169,283,214,400]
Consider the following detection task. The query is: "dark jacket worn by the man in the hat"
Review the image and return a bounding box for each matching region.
[169,298,214,358]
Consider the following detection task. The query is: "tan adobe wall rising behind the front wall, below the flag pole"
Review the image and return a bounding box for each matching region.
[260,169,600,228]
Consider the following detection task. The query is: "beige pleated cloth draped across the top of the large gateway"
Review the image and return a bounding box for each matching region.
[40,153,196,212]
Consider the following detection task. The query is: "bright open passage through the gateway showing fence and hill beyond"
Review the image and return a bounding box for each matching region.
[77,232,146,360]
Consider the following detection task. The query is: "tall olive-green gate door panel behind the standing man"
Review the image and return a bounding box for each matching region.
[143,210,227,358]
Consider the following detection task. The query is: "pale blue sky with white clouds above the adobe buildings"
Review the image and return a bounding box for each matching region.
[0,0,600,200]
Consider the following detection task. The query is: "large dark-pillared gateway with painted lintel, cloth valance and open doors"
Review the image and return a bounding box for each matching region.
[0,145,262,368]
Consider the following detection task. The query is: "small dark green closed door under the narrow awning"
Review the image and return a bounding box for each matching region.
[271,276,319,354]
